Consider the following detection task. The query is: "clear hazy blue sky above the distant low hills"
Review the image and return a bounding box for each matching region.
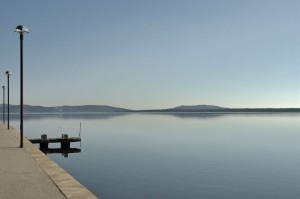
[0,0,300,109]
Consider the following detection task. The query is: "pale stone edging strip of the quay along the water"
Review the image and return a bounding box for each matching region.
[11,128,98,199]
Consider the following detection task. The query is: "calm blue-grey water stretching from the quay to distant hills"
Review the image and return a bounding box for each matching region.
[11,113,300,199]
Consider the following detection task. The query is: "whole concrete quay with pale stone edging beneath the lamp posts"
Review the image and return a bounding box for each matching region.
[0,124,97,199]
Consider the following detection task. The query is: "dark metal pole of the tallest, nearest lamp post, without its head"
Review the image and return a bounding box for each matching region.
[20,33,23,148]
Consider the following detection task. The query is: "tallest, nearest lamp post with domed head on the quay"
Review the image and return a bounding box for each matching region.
[14,25,29,148]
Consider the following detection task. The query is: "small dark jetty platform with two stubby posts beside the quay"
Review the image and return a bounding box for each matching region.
[29,134,81,149]
